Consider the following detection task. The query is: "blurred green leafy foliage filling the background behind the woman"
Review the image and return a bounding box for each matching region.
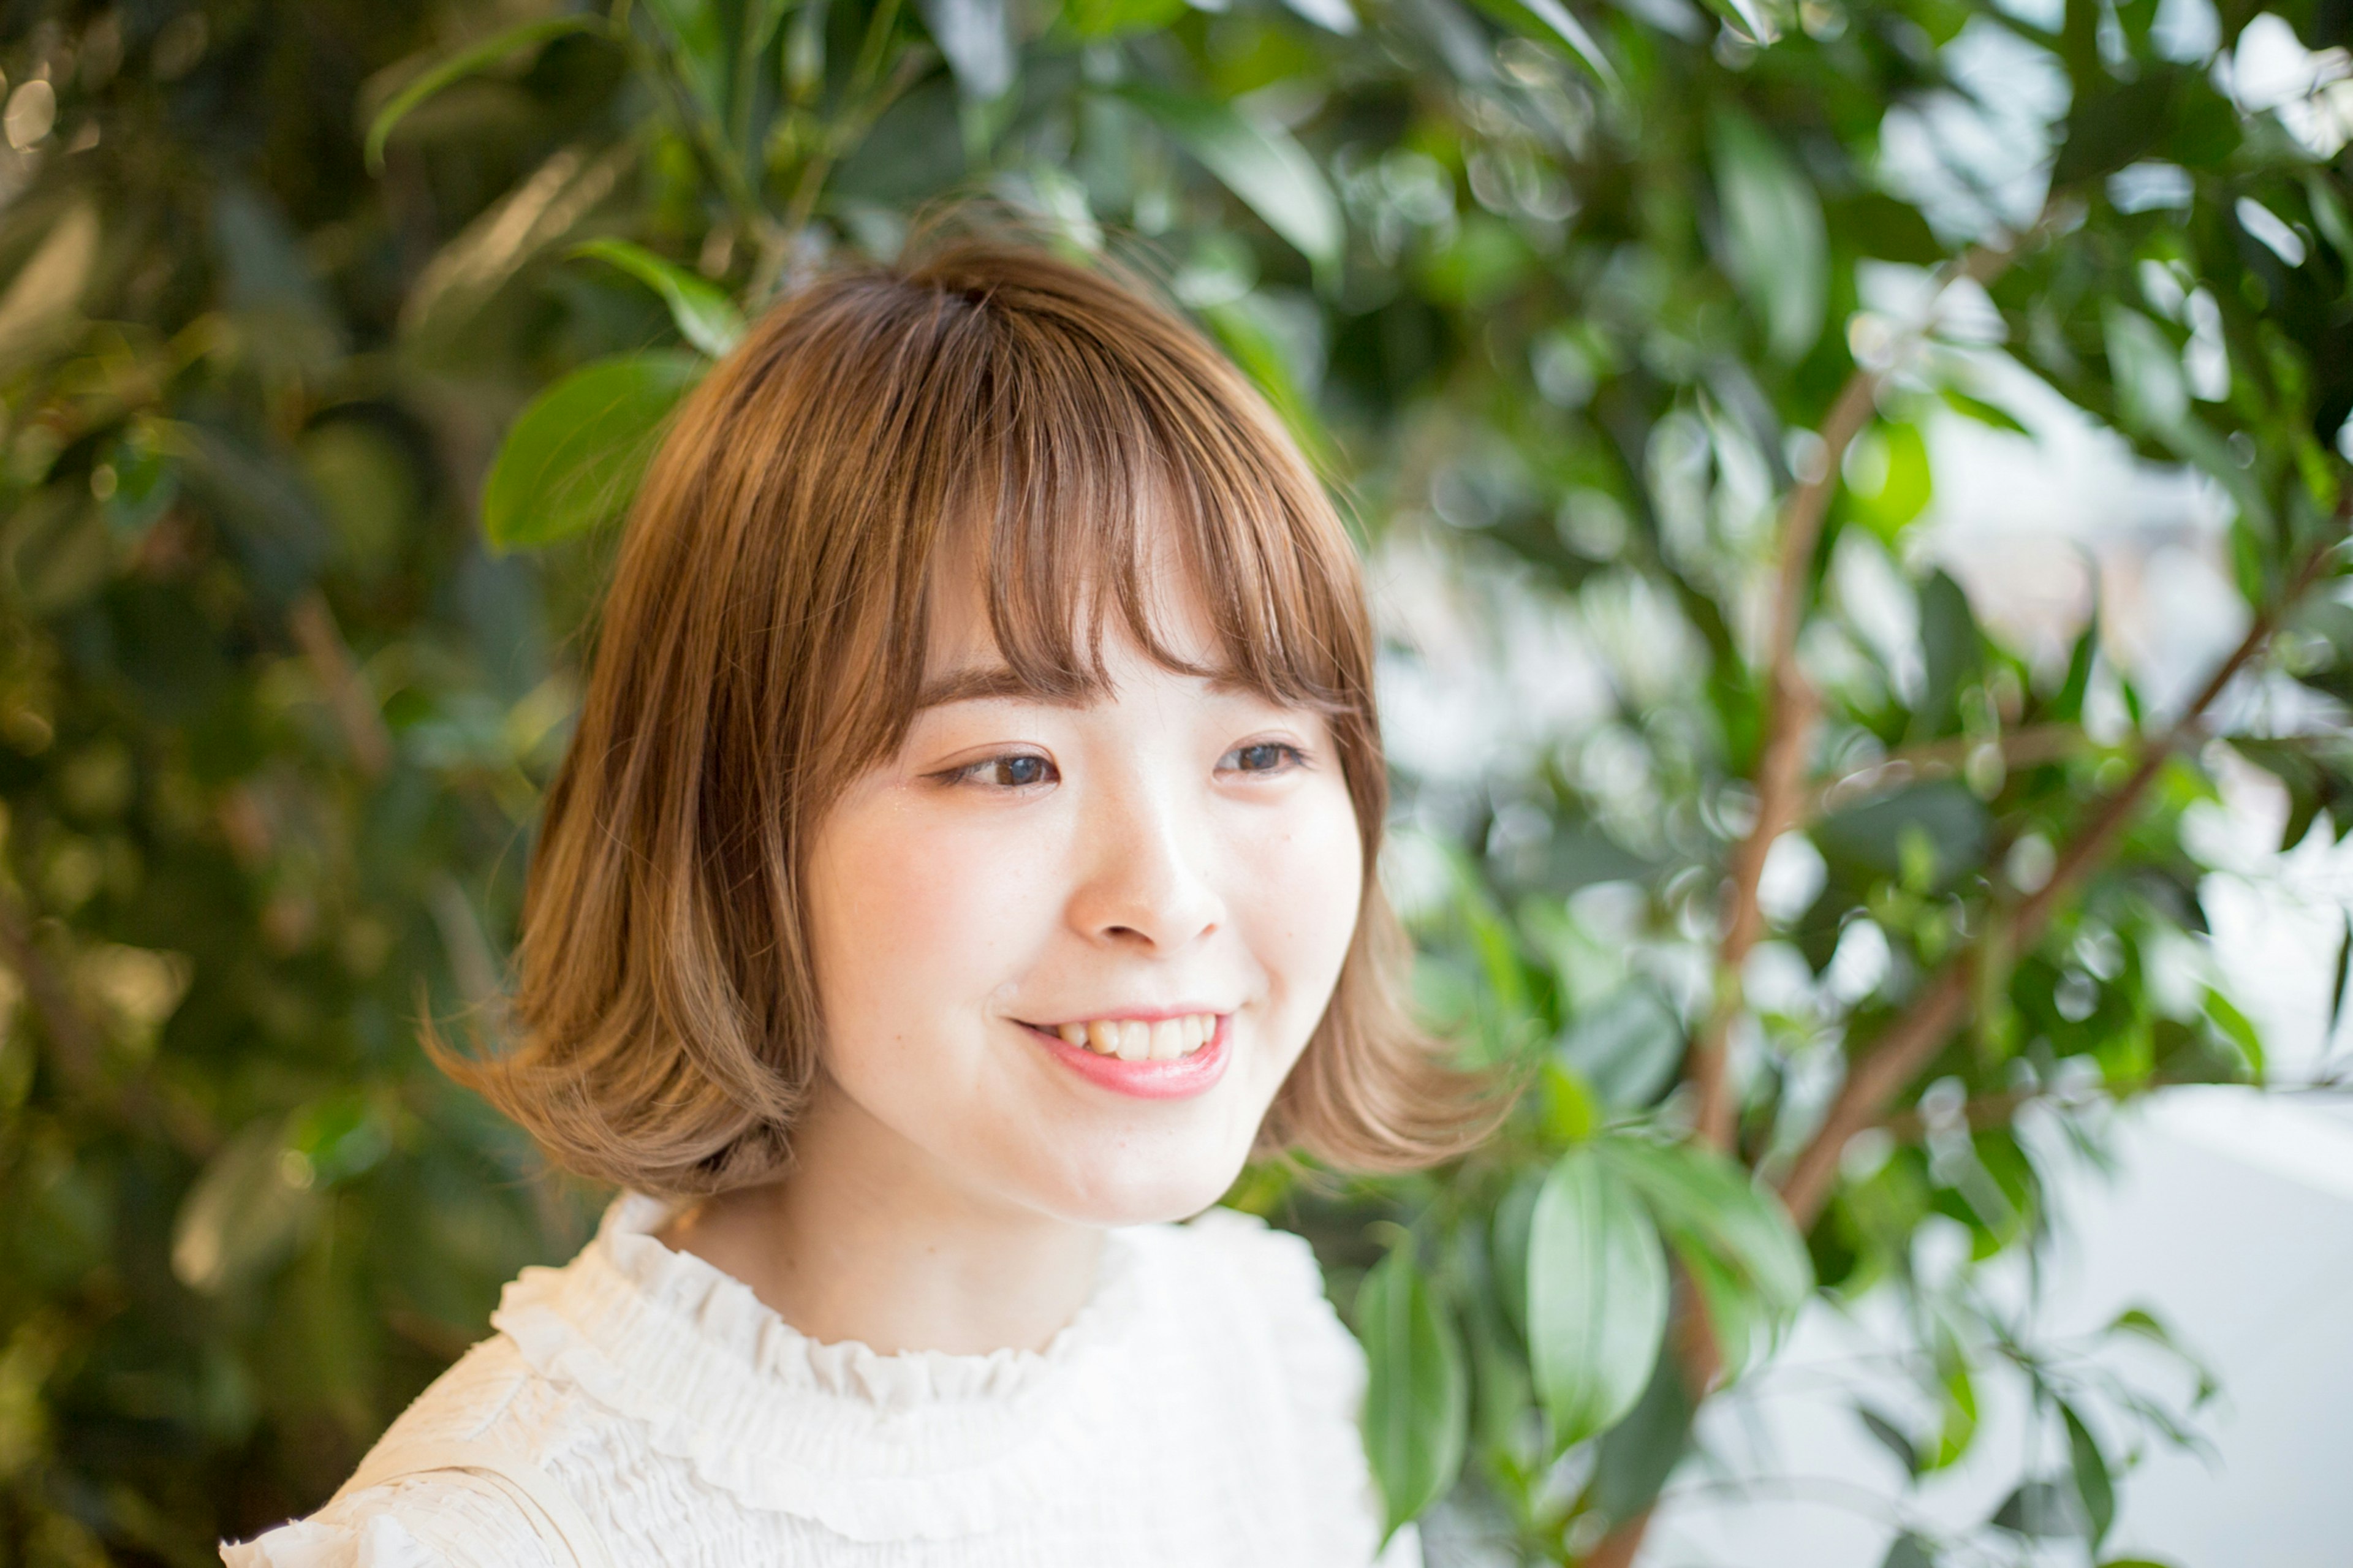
[0,0,2353,1568]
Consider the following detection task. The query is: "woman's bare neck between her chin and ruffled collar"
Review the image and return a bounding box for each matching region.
[656,1083,1104,1356]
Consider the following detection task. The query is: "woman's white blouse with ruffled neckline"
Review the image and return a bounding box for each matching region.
[221,1194,1419,1568]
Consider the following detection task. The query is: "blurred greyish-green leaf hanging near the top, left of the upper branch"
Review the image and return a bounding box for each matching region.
[1708,111,1831,363]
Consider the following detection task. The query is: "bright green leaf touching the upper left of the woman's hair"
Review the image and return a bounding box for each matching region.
[482,351,708,551]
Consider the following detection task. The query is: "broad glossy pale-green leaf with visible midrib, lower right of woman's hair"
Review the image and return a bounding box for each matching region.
[1527,1144,1666,1448]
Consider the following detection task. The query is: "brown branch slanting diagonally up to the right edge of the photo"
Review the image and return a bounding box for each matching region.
[1781,525,2344,1229]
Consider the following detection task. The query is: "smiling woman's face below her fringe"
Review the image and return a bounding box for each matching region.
[807,546,1362,1224]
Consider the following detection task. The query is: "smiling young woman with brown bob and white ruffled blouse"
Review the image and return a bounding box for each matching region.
[226,225,1487,1568]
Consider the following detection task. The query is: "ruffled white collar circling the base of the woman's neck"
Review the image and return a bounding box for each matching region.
[490,1194,1172,1542]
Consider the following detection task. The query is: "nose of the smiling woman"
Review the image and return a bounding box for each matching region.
[1070,779,1226,953]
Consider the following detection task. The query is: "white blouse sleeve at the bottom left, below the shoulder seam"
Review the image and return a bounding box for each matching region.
[221,1471,572,1568]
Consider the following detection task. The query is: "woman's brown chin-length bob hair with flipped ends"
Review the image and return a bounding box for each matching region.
[444,222,1494,1196]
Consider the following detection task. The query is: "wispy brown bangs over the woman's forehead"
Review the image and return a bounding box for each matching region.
[845,279,1360,781]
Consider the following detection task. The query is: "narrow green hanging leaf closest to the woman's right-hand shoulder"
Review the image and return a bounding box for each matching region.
[1355,1243,1471,1537]
